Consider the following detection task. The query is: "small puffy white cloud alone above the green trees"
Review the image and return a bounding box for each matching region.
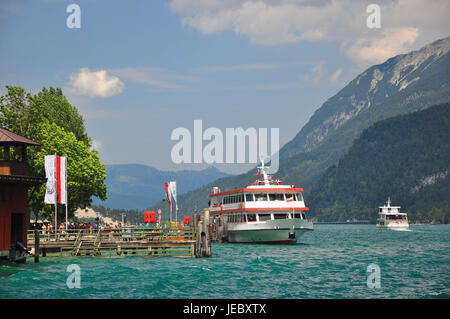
[70,68,125,98]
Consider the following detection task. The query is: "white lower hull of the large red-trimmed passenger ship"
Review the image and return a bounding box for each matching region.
[228,219,313,244]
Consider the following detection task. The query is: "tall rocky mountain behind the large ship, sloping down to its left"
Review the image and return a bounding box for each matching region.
[151,37,450,220]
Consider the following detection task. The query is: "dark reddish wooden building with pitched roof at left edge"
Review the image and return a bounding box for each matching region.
[0,128,46,261]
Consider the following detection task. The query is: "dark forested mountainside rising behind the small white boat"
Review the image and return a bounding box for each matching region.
[309,103,450,223]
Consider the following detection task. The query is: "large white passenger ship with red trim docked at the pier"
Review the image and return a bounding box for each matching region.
[209,162,313,244]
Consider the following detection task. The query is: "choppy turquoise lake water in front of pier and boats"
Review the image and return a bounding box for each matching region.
[0,225,450,299]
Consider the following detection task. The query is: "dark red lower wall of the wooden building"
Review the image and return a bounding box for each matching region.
[0,185,29,250]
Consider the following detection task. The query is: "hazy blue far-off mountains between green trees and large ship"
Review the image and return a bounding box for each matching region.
[93,164,229,209]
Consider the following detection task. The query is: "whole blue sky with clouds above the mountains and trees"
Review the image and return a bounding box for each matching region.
[0,0,450,172]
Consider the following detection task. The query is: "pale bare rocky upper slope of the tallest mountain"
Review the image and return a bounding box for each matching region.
[280,38,450,157]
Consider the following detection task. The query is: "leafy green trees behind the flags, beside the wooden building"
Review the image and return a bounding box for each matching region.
[0,86,107,216]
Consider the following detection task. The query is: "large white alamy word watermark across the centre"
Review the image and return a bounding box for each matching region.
[170,120,280,174]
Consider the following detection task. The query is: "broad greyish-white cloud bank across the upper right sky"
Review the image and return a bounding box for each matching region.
[170,0,450,67]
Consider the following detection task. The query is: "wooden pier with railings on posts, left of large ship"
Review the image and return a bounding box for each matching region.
[28,227,211,260]
